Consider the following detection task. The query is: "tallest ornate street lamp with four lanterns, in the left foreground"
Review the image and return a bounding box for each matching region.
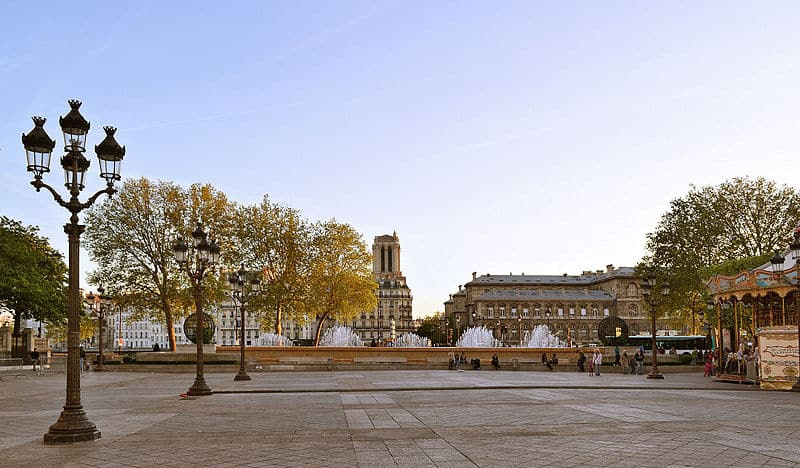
[22,99,125,444]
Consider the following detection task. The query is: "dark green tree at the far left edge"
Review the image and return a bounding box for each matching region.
[0,216,67,354]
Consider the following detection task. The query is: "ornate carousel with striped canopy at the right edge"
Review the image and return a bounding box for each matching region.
[706,226,800,391]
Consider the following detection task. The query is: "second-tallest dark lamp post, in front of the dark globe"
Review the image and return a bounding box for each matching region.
[172,223,219,396]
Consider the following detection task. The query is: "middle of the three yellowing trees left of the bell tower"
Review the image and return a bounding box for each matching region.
[234,196,311,335]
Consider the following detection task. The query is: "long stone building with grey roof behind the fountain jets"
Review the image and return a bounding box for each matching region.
[444,265,666,345]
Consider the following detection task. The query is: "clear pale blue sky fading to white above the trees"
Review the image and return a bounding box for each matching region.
[0,1,800,317]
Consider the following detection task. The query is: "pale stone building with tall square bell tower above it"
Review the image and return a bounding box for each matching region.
[348,232,415,343]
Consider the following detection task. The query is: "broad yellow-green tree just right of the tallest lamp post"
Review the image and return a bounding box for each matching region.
[86,178,231,351]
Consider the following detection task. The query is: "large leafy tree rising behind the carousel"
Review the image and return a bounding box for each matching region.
[643,177,800,332]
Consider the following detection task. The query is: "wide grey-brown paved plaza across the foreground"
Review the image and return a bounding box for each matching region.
[0,370,800,468]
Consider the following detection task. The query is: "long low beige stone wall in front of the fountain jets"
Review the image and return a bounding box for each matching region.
[216,346,600,369]
